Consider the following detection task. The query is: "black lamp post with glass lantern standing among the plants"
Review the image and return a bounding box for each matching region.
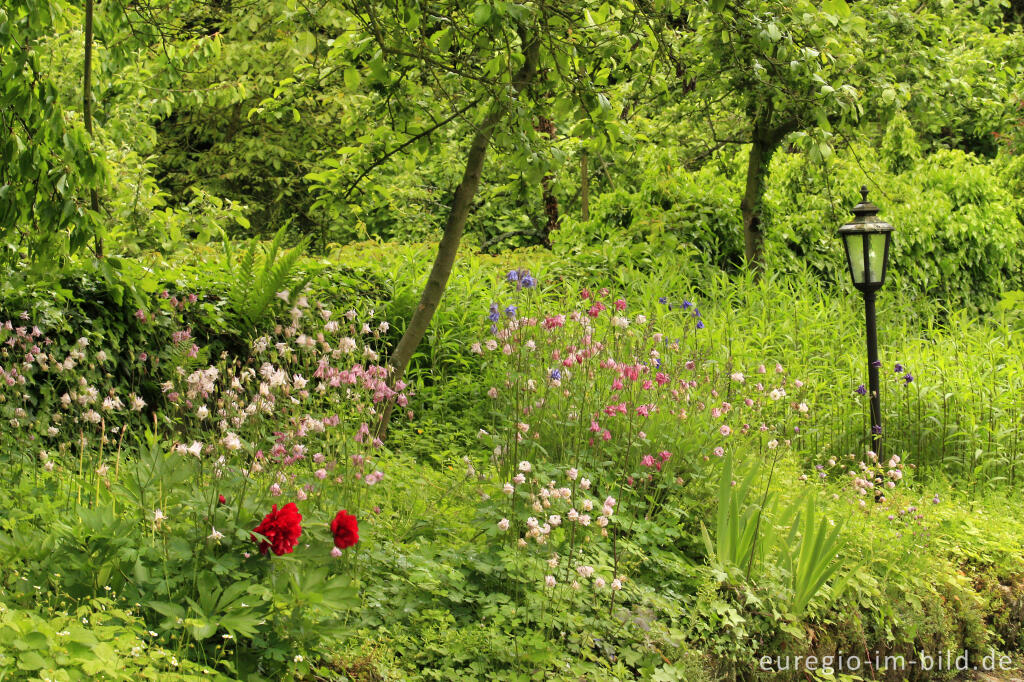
[839,186,893,457]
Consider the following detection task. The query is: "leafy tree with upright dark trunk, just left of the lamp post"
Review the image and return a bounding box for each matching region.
[648,0,1019,266]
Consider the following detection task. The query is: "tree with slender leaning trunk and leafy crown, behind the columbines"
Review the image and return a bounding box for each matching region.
[315,0,632,433]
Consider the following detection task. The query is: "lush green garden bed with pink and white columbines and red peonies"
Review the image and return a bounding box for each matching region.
[0,242,1024,679]
